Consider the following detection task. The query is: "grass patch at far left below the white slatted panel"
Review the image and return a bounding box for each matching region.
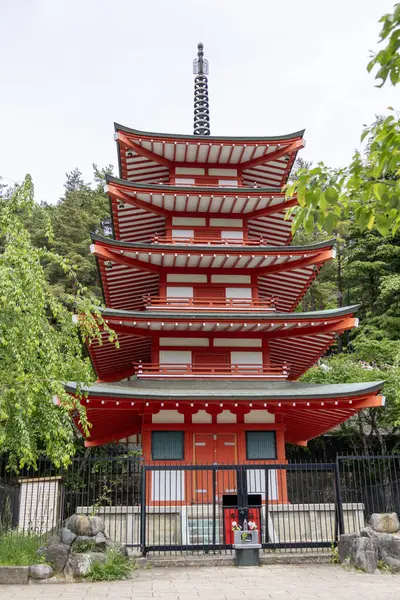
[0,531,43,567]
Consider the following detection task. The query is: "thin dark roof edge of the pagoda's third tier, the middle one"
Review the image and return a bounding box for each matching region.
[90,232,336,254]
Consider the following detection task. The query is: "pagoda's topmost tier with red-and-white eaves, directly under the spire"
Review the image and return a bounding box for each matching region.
[115,123,304,188]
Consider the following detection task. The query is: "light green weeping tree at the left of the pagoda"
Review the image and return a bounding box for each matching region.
[0,176,113,468]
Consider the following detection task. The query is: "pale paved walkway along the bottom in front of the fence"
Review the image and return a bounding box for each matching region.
[0,565,400,600]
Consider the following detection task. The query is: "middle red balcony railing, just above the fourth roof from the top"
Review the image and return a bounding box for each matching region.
[143,296,276,312]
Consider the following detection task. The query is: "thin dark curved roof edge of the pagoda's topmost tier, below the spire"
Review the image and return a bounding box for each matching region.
[114,123,305,143]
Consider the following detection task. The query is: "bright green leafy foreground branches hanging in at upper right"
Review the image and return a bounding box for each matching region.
[286,3,400,235]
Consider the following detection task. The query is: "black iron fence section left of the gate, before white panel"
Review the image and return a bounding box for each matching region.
[0,456,142,545]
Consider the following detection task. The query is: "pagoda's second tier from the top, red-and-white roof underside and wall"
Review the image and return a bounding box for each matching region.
[105,176,297,246]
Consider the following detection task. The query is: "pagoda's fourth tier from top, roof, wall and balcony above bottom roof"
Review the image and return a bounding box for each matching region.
[89,306,358,381]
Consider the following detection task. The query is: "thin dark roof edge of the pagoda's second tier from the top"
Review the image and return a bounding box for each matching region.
[106,173,282,196]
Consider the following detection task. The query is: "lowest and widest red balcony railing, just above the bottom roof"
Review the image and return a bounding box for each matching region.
[134,356,289,380]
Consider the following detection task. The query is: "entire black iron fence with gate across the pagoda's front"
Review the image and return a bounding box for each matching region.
[0,456,400,553]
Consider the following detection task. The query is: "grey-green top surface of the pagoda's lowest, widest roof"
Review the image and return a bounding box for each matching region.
[65,378,385,402]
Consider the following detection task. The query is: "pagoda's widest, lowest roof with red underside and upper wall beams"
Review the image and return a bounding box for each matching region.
[66,378,384,450]
